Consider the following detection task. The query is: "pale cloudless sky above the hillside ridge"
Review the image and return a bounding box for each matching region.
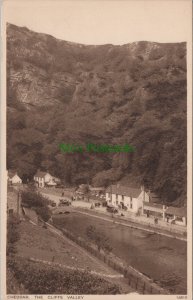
[3,0,192,45]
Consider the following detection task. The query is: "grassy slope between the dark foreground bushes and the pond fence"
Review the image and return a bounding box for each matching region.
[13,222,131,293]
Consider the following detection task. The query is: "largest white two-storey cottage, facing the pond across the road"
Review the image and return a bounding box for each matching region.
[106,185,149,213]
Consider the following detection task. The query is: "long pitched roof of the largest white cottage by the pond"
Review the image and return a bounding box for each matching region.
[106,185,141,198]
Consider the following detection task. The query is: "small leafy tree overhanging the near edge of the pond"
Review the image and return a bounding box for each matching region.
[86,225,112,252]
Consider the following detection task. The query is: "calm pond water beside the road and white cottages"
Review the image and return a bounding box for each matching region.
[52,212,187,294]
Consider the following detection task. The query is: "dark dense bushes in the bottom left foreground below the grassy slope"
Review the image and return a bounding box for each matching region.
[8,259,120,295]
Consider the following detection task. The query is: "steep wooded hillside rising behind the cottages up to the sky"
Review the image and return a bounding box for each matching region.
[7,24,186,205]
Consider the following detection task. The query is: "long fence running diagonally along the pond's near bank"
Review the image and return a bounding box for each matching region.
[55,226,169,295]
